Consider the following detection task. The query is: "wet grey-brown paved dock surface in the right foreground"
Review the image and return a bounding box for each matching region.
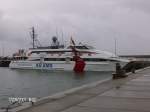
[19,68,150,112]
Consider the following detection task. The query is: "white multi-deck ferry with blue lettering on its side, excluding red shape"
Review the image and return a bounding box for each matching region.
[9,36,128,71]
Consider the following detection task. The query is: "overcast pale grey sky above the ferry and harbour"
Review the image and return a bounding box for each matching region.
[0,0,150,55]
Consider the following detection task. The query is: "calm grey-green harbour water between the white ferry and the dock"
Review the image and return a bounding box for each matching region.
[0,68,112,107]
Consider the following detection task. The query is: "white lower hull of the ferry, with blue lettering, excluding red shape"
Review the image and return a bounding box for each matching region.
[9,61,119,71]
